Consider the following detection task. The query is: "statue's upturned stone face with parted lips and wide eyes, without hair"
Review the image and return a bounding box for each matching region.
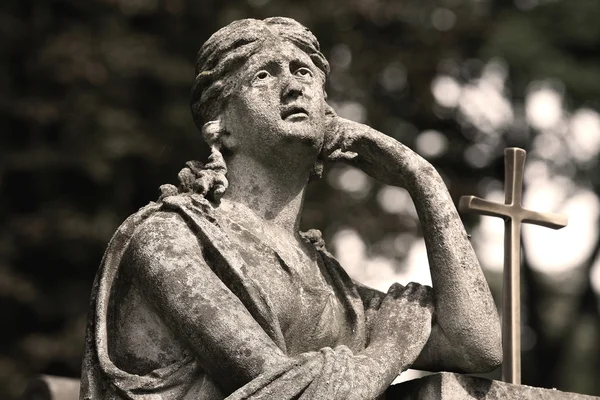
[222,40,326,165]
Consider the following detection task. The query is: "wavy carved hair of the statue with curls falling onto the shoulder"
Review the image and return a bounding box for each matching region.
[184,17,329,201]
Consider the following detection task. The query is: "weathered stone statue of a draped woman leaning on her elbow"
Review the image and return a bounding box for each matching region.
[81,18,501,399]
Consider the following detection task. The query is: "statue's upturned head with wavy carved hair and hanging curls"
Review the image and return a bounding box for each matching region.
[188,17,329,202]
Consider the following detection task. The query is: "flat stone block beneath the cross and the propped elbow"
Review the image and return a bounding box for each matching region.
[386,372,600,400]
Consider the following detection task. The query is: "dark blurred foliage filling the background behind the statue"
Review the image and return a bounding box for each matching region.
[0,0,600,399]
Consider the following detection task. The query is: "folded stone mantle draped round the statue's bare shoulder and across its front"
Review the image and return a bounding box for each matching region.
[80,194,376,400]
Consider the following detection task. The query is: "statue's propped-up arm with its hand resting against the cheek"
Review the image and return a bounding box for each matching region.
[324,114,502,372]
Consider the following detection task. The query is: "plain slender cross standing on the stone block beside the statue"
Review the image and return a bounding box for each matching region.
[458,147,567,384]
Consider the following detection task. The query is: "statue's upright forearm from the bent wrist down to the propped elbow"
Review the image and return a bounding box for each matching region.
[407,166,501,370]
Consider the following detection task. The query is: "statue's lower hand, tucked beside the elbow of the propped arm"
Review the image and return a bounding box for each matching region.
[371,282,434,367]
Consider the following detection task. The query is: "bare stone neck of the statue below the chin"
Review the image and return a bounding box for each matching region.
[223,156,310,236]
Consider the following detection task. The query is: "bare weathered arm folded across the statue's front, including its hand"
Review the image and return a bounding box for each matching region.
[128,209,432,399]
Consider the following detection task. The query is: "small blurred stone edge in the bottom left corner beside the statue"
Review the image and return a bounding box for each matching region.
[21,375,79,400]
